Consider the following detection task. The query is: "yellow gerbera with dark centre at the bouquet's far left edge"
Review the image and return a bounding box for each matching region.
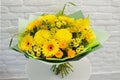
[19,34,33,51]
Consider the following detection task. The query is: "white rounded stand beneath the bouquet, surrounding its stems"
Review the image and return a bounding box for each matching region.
[27,58,91,80]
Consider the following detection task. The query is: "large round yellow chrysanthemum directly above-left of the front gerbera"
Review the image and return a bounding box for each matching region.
[34,30,50,45]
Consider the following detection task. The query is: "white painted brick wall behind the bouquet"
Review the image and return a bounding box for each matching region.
[0,0,120,80]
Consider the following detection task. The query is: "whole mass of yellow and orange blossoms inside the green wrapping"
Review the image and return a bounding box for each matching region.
[18,14,95,59]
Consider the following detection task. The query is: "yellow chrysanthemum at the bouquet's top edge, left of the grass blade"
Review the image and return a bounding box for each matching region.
[42,14,57,24]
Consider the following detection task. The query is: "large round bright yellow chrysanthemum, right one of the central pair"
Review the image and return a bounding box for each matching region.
[55,29,72,42]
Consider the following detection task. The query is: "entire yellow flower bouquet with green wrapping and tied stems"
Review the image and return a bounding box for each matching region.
[10,2,109,77]
